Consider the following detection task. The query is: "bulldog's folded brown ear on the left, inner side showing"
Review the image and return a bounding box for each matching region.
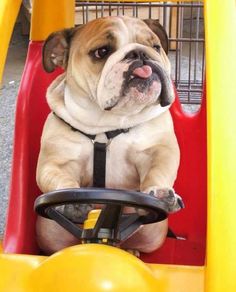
[43,27,77,73]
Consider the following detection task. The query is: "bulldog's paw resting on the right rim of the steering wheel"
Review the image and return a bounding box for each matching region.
[145,187,184,213]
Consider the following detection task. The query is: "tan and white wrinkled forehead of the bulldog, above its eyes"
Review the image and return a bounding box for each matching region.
[75,16,158,48]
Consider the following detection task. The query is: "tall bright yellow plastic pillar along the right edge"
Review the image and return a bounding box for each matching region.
[205,0,236,292]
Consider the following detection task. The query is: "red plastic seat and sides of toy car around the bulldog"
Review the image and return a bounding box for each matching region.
[4,42,207,265]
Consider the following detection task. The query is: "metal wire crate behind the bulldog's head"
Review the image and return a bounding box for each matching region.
[76,1,205,104]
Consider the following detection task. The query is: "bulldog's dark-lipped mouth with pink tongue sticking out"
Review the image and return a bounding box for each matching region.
[105,59,171,110]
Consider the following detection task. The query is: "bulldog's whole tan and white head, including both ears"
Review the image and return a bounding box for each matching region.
[43,17,174,114]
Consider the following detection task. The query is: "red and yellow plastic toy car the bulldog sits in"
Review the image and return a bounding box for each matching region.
[0,0,236,292]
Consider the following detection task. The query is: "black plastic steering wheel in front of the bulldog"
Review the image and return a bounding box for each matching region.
[34,188,171,245]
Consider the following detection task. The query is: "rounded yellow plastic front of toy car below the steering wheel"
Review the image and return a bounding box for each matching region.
[0,244,204,292]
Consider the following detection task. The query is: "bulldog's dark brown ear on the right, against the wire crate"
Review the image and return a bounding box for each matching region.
[143,19,169,54]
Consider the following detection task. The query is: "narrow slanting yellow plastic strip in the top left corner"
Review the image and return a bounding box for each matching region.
[0,0,22,84]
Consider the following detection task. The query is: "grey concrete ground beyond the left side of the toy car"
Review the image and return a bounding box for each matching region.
[0,20,200,235]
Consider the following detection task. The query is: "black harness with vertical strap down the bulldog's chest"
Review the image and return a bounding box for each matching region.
[53,113,129,188]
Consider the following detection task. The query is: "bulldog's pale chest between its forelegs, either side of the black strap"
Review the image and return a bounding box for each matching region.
[80,134,145,189]
